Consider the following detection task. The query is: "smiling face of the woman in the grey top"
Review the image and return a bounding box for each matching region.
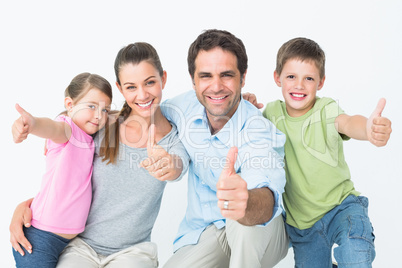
[116,61,166,118]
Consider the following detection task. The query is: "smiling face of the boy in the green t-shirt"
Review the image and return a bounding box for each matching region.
[274,59,325,117]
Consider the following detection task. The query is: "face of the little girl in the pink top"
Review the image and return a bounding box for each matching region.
[65,88,112,135]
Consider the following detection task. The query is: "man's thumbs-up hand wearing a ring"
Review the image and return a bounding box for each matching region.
[216,147,248,221]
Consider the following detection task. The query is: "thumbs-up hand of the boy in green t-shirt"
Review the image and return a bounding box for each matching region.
[366,99,392,147]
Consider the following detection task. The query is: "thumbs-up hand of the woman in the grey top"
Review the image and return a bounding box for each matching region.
[140,124,183,181]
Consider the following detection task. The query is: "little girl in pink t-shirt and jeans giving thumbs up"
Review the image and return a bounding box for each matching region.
[12,73,112,268]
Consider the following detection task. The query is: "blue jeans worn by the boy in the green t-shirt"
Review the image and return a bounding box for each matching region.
[286,195,375,268]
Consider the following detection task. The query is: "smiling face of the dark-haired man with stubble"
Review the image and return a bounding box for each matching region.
[193,47,246,123]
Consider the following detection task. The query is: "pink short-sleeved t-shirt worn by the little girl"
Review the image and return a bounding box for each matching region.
[31,116,95,234]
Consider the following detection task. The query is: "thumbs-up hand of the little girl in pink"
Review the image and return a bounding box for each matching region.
[11,104,35,143]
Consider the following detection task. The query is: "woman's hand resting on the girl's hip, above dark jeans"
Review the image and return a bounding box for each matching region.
[10,198,33,256]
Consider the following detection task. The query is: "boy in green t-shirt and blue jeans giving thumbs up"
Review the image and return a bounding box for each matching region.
[263,38,391,268]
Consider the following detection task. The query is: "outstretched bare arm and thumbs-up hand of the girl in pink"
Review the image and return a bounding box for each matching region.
[12,104,71,143]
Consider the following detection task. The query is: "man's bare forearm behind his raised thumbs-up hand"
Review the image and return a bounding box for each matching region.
[238,187,275,226]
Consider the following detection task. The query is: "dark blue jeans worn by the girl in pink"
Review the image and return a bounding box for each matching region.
[13,226,70,268]
